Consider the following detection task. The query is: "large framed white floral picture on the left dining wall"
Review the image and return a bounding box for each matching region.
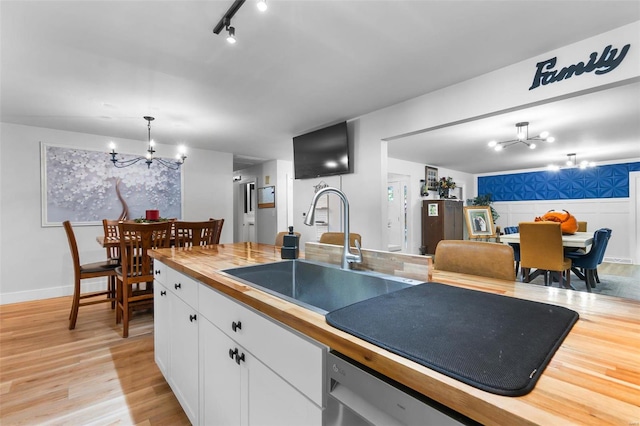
[40,142,184,227]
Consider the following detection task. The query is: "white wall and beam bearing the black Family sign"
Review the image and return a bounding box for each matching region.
[294,22,640,255]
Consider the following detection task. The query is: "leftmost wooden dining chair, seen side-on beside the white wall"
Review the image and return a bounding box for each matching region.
[62,220,118,330]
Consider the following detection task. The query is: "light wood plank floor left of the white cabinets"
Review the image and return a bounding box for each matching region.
[0,297,189,425]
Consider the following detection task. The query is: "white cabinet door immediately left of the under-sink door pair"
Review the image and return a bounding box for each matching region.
[167,292,198,424]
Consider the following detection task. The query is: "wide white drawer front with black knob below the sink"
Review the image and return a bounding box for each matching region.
[198,284,326,407]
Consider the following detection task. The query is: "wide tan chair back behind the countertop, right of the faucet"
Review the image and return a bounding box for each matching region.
[433,240,516,281]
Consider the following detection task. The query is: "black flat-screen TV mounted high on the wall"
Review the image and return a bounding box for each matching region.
[293,122,353,179]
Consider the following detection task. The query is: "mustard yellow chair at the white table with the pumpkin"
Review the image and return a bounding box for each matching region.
[518,221,571,288]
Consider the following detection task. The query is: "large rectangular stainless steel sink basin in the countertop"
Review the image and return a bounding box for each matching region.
[222,260,422,315]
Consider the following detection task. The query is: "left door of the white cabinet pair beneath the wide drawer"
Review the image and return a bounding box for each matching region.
[199,319,246,425]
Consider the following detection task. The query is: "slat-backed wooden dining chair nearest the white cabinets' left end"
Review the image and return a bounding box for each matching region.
[116,222,171,337]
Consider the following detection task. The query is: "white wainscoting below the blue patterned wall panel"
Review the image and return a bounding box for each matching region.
[493,198,638,264]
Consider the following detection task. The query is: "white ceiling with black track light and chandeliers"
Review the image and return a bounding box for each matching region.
[0,0,640,173]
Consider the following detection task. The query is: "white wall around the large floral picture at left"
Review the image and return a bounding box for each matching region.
[0,123,233,304]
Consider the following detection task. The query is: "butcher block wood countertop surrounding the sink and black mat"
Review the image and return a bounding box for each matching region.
[151,243,640,426]
